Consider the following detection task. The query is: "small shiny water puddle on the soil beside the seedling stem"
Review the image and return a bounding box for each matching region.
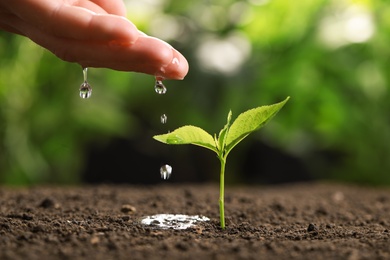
[141,214,210,230]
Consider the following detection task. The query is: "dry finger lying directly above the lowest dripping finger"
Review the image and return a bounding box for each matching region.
[9,0,138,44]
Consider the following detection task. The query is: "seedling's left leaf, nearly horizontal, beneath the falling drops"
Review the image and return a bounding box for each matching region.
[153,125,218,153]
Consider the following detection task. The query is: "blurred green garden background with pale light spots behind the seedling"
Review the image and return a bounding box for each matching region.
[0,0,390,184]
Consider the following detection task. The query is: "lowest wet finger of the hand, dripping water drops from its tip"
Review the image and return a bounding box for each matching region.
[0,7,188,79]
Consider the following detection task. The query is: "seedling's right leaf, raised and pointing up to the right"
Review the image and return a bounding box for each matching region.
[225,97,290,156]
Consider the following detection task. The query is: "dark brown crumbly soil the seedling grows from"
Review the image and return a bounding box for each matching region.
[0,183,390,260]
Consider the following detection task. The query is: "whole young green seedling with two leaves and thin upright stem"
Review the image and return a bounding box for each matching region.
[153,97,290,229]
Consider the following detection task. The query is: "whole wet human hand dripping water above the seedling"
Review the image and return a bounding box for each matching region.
[0,0,188,79]
